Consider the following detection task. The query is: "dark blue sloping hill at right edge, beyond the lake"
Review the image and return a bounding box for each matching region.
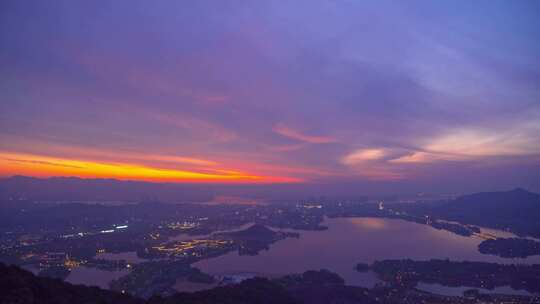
[433,188,540,236]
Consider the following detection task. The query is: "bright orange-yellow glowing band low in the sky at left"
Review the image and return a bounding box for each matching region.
[0,152,301,183]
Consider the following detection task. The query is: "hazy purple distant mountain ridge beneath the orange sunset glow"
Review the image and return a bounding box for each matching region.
[0,176,358,202]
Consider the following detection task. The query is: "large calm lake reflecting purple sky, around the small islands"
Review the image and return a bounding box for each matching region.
[194,218,540,286]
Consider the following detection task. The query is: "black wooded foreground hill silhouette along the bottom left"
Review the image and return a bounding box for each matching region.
[0,263,350,304]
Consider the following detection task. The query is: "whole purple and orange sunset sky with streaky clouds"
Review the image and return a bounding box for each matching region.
[0,0,540,190]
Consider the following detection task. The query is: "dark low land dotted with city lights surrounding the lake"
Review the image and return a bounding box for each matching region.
[0,177,540,303]
